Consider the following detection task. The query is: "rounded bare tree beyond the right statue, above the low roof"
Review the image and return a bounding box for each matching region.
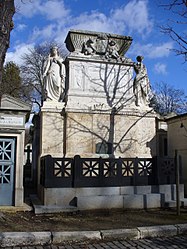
[152,82,187,115]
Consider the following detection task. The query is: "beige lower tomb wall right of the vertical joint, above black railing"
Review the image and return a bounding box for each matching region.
[66,109,156,157]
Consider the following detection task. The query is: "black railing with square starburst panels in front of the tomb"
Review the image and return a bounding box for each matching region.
[40,155,178,188]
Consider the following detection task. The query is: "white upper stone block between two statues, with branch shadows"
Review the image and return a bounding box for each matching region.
[66,56,134,110]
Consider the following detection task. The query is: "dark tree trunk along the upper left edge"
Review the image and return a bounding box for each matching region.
[0,0,15,84]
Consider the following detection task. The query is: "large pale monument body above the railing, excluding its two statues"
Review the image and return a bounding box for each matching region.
[40,30,156,157]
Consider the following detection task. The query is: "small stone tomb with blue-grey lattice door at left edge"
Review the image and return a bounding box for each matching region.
[0,95,31,206]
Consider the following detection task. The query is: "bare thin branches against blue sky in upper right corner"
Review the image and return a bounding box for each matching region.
[160,0,187,62]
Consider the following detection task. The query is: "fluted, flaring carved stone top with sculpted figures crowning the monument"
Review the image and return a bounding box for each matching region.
[65,30,132,59]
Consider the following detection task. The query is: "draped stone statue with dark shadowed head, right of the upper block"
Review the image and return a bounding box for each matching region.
[133,56,150,106]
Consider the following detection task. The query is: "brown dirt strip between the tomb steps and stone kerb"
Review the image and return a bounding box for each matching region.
[0,209,187,232]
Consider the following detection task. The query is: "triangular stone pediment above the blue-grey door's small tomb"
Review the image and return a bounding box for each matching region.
[0,94,31,112]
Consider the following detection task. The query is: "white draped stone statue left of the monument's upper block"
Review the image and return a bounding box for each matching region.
[43,47,65,101]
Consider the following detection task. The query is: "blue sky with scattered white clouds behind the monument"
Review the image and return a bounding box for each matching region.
[6,0,187,95]
